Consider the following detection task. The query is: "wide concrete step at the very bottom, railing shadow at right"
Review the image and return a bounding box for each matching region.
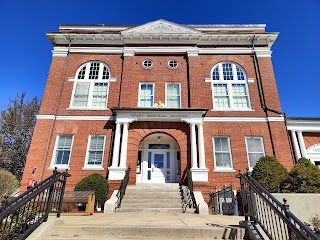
[43,225,244,240]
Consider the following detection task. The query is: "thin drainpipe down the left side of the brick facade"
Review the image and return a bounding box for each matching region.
[40,34,71,181]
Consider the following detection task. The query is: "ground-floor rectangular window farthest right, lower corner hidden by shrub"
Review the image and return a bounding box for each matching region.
[246,137,265,168]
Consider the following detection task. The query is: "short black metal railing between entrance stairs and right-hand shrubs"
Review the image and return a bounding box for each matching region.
[209,185,235,215]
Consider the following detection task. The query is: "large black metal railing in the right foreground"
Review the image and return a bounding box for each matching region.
[237,171,319,240]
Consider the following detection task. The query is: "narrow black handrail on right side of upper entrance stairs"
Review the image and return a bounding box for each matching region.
[181,166,197,212]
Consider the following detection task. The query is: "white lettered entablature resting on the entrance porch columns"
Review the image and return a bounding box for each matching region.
[112,108,208,122]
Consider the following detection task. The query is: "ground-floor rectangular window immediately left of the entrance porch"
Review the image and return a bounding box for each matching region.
[87,135,106,167]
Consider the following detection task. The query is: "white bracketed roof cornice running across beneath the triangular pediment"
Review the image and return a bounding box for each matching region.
[47,32,278,48]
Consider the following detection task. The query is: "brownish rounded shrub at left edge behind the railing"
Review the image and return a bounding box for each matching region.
[0,168,19,199]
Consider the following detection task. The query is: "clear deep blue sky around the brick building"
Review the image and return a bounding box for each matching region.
[0,0,320,117]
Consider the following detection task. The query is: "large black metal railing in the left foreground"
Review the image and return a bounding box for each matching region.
[0,169,70,240]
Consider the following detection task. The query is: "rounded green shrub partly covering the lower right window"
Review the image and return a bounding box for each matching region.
[252,156,288,192]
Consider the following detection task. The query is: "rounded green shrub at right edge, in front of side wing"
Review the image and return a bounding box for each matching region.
[287,158,320,193]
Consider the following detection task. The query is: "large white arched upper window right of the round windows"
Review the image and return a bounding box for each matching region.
[211,62,251,110]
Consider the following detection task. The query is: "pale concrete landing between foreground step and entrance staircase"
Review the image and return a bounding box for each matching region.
[61,212,244,228]
